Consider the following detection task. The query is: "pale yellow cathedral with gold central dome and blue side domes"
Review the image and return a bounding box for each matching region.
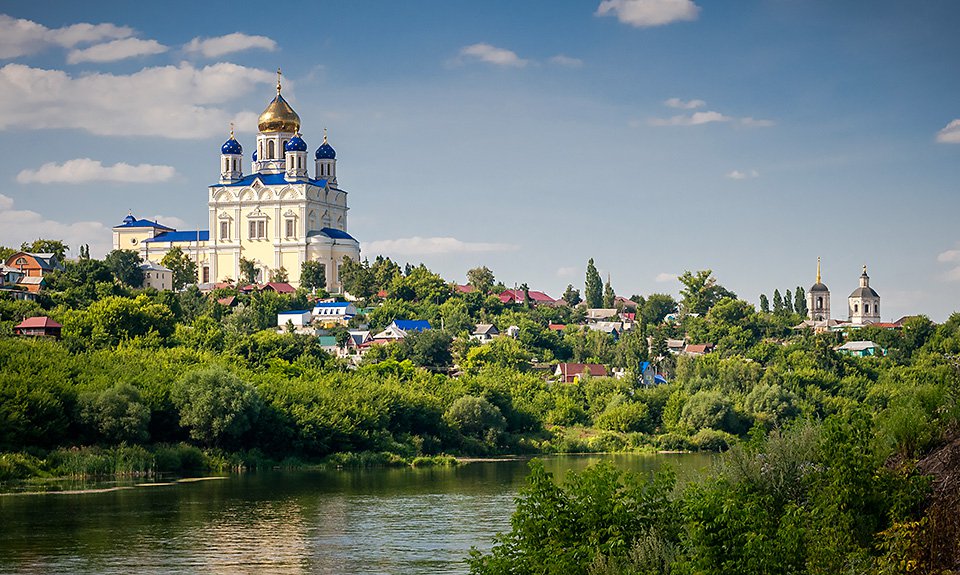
[113,71,360,292]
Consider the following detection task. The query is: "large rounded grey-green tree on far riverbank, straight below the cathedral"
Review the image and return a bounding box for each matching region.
[171,367,261,446]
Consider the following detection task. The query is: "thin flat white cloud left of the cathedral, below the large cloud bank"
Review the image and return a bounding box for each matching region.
[17,158,177,184]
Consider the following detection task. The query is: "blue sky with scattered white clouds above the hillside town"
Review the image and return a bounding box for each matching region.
[0,0,960,321]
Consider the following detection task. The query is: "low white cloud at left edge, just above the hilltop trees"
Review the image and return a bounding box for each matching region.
[0,194,113,257]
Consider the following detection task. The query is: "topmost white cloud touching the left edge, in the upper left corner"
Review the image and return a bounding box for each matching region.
[0,14,133,58]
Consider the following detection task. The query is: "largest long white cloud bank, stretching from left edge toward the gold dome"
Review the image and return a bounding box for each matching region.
[0,62,276,139]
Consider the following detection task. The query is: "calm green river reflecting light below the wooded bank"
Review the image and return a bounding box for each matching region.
[0,455,709,575]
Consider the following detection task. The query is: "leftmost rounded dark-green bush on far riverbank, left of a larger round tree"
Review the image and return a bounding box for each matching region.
[80,383,150,444]
